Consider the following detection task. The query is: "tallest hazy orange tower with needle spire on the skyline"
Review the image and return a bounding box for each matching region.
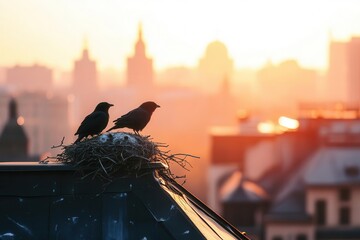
[127,23,154,88]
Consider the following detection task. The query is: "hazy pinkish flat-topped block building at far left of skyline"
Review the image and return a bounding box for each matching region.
[6,64,53,92]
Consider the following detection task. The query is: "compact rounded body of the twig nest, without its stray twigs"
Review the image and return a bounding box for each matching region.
[57,132,159,178]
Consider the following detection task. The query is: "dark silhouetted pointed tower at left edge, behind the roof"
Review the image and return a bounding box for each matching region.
[0,99,39,162]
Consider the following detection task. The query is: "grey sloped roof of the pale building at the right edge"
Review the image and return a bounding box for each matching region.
[266,146,360,222]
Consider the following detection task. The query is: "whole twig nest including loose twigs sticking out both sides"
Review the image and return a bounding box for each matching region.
[46,132,198,181]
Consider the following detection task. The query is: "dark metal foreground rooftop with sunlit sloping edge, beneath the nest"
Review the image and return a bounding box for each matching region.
[0,162,247,239]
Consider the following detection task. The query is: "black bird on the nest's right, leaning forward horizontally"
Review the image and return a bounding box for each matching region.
[107,102,160,134]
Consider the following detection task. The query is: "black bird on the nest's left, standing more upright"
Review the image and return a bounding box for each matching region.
[74,102,114,143]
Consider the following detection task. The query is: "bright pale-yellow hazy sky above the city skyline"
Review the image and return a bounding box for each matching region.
[0,0,360,70]
